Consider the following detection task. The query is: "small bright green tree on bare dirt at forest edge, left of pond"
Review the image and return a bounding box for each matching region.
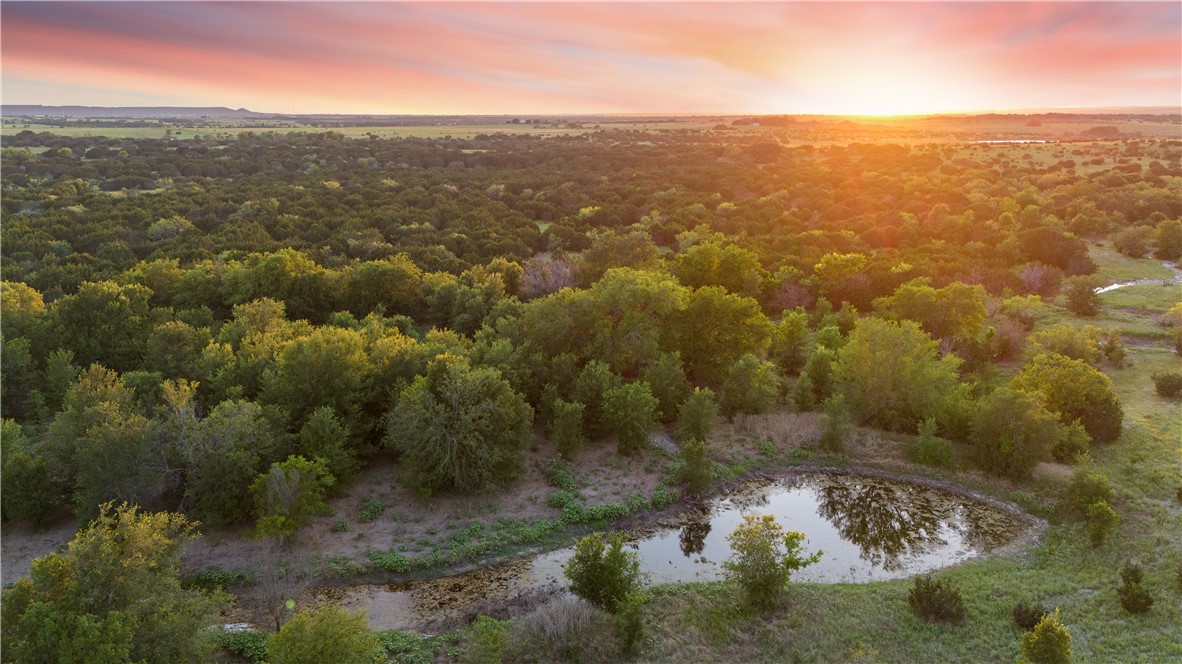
[251,456,335,539]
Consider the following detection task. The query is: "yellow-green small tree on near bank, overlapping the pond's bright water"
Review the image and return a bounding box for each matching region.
[722,514,821,610]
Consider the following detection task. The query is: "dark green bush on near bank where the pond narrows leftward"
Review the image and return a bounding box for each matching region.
[563,532,641,613]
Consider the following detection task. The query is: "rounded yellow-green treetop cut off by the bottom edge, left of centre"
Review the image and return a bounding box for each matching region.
[267,604,385,664]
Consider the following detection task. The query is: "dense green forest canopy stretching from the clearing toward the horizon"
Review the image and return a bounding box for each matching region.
[2,119,1182,523]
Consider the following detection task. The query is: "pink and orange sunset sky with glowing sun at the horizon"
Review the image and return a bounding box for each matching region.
[0,0,1182,115]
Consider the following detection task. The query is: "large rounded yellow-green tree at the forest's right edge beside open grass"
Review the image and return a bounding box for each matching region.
[1011,353,1124,443]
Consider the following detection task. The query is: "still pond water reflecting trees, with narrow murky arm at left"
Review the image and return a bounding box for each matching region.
[314,473,1027,629]
